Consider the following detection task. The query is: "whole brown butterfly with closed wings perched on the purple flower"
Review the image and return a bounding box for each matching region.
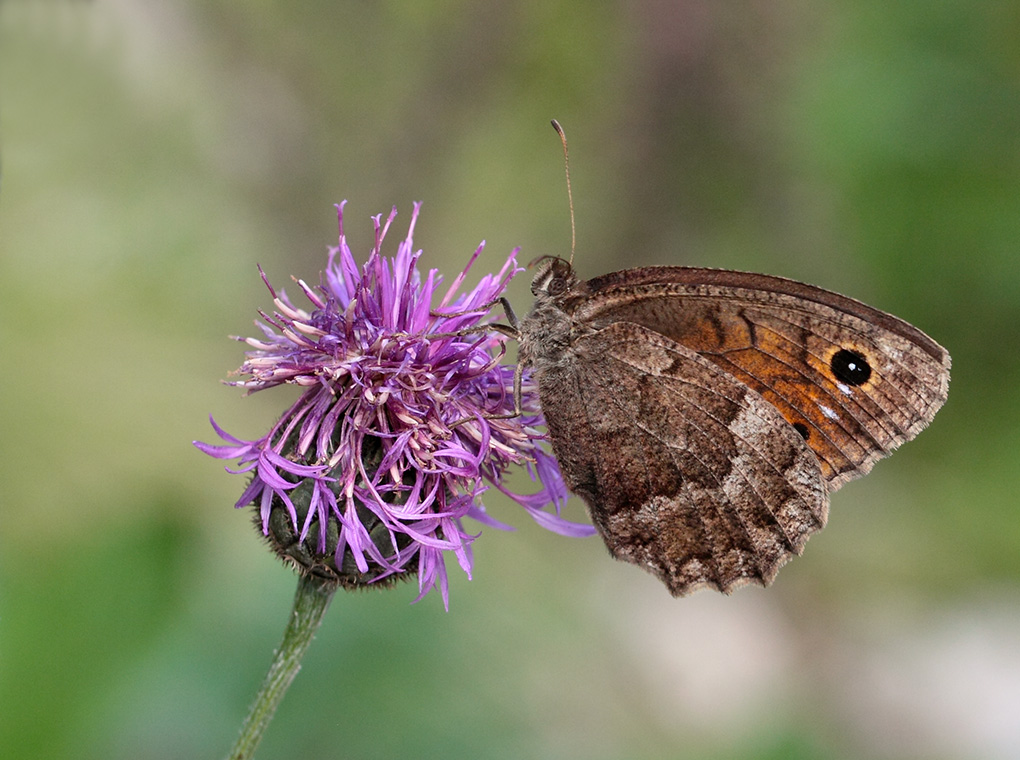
[508,122,950,596]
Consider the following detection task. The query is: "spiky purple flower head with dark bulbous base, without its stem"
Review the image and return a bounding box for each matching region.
[195,203,594,605]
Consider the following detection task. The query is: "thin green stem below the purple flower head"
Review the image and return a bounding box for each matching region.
[226,575,337,760]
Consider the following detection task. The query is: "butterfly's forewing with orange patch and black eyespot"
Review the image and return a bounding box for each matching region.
[572,267,950,490]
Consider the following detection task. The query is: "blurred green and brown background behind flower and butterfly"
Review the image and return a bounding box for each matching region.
[0,0,1020,760]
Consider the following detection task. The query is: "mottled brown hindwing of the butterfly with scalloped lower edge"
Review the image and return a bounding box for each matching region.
[540,322,827,595]
